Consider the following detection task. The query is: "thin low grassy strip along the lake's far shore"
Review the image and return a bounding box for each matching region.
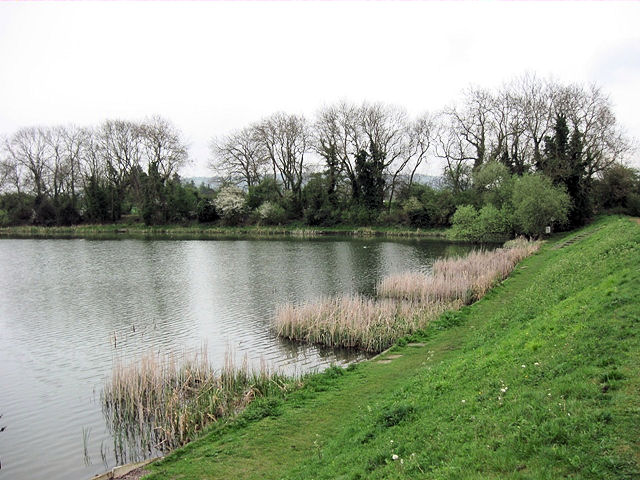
[0,223,446,239]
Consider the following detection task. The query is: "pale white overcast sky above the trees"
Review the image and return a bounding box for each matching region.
[0,1,640,176]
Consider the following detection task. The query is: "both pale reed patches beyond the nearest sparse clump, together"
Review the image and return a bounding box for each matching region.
[274,239,539,352]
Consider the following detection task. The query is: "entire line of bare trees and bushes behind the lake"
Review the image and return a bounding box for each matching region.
[0,75,640,238]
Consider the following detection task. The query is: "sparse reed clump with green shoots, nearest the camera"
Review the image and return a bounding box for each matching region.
[101,349,287,461]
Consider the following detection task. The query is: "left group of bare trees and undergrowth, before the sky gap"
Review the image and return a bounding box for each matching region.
[0,117,192,225]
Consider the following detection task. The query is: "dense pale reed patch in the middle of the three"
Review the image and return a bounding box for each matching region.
[275,295,459,352]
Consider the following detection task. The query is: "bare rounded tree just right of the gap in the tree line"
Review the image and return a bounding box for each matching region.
[209,126,269,187]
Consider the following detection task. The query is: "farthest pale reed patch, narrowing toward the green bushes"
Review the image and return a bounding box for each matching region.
[377,239,540,304]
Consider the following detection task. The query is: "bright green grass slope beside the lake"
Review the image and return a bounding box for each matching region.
[142,218,640,480]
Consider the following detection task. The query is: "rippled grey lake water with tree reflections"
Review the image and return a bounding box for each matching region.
[0,239,476,479]
